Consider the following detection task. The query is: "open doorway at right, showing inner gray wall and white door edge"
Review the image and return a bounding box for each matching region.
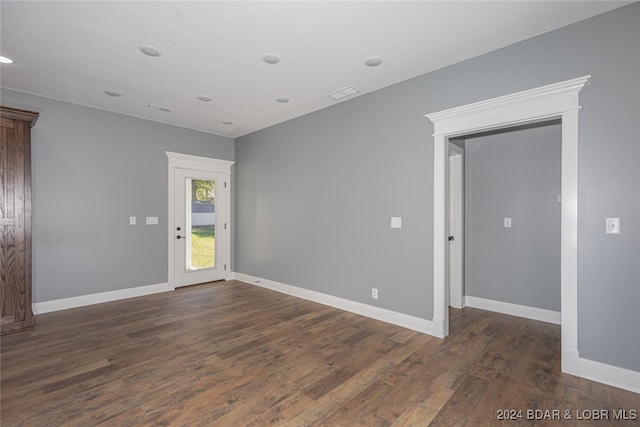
[446,120,561,324]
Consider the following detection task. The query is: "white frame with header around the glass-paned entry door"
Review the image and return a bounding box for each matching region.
[166,151,235,290]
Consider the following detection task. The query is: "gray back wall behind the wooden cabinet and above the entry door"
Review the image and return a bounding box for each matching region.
[1,90,234,302]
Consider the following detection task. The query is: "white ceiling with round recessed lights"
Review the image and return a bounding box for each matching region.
[0,0,631,137]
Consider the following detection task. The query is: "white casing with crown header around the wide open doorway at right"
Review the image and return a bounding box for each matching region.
[426,75,591,375]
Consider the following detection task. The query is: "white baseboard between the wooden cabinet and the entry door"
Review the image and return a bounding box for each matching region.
[32,283,171,314]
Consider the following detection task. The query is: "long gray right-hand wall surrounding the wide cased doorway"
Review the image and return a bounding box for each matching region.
[235,3,640,371]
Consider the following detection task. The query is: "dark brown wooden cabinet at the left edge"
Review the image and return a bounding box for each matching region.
[0,107,38,334]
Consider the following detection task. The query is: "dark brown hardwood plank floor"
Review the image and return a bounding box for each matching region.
[0,281,640,427]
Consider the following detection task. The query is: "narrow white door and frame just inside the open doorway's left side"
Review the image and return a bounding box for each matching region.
[447,142,464,308]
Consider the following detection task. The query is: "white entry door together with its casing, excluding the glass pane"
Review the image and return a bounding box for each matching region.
[167,152,235,289]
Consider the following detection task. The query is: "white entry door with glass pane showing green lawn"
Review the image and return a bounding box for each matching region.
[169,152,230,287]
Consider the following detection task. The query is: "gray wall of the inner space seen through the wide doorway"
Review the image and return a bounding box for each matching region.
[464,123,562,311]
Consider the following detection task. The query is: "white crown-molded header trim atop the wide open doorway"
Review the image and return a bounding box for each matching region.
[425,76,591,136]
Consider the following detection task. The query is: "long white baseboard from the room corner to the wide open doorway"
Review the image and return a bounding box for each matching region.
[234,272,436,335]
